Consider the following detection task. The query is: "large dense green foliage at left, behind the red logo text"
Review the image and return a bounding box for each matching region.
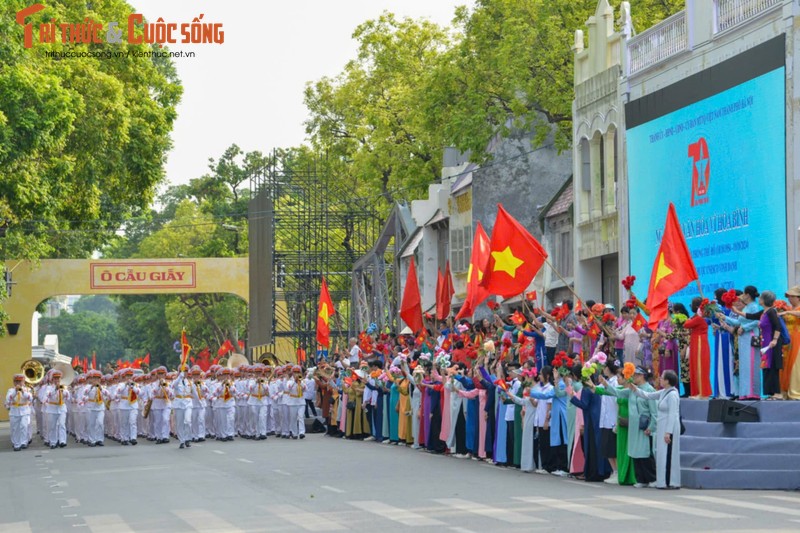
[0,0,182,259]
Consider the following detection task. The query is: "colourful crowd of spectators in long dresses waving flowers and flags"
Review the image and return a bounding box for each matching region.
[317,286,800,488]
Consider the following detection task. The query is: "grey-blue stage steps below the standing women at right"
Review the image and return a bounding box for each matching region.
[681,400,800,490]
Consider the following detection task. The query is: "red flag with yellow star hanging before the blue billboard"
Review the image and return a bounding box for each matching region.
[647,203,699,328]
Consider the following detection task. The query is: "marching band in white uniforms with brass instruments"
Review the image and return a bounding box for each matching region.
[5,364,316,451]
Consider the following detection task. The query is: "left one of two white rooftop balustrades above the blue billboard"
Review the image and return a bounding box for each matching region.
[628,11,689,76]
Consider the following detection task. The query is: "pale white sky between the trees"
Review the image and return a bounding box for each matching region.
[128,0,472,188]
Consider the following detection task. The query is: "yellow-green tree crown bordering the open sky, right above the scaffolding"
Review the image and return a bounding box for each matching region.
[305,13,450,214]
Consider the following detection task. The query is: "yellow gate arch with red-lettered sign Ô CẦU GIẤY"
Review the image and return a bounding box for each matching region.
[0,257,291,420]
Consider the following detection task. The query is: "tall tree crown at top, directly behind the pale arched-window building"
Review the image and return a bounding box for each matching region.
[424,0,684,158]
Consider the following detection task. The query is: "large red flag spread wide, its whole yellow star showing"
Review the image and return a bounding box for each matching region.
[481,204,547,298]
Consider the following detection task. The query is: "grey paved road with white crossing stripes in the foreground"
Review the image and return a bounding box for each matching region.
[0,425,800,533]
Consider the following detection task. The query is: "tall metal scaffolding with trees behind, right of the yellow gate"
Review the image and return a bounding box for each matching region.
[250,152,381,360]
